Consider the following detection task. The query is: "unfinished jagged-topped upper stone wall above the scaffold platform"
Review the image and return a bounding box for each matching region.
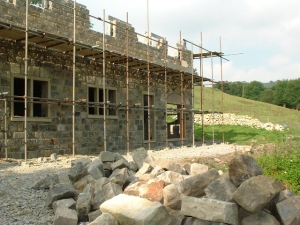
[0,0,192,73]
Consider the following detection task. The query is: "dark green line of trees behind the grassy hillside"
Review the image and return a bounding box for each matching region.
[214,78,300,109]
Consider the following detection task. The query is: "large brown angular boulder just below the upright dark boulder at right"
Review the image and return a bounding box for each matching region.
[233,175,285,213]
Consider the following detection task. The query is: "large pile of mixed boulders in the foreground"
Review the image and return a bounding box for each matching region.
[33,148,300,225]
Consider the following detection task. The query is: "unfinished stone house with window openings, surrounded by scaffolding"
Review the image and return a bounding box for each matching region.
[0,0,209,158]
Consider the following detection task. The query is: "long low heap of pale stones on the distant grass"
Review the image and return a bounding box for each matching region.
[194,113,284,131]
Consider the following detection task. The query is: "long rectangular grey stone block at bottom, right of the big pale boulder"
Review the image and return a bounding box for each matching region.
[181,196,238,224]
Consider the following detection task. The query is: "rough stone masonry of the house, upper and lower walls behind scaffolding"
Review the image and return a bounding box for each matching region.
[0,0,197,159]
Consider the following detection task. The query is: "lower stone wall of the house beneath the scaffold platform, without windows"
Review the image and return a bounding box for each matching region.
[0,39,192,158]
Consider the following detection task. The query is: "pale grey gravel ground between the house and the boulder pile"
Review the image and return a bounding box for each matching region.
[0,145,245,225]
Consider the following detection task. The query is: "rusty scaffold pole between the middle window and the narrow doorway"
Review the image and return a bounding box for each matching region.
[126,12,130,154]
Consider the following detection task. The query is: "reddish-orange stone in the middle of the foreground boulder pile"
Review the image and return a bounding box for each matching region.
[124,179,165,202]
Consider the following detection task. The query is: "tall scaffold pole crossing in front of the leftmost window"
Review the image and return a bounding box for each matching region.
[24,0,29,163]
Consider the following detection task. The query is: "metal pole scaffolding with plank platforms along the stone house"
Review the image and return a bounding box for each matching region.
[0,0,227,162]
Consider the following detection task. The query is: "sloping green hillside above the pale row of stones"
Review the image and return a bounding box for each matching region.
[194,86,300,134]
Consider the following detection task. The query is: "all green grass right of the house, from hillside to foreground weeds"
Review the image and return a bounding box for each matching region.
[195,87,300,195]
